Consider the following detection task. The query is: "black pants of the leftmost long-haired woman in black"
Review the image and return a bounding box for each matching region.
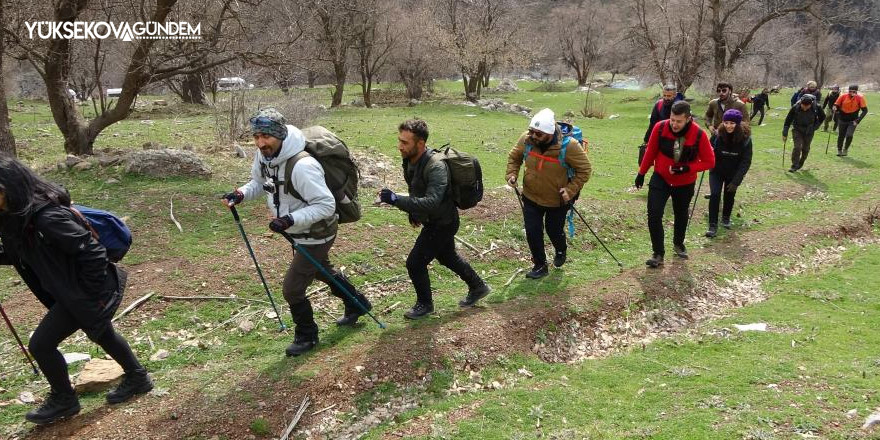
[28,303,143,393]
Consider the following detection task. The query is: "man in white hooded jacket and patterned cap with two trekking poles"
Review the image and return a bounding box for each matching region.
[223,108,372,356]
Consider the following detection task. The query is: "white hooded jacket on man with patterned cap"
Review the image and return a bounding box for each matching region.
[238,125,337,244]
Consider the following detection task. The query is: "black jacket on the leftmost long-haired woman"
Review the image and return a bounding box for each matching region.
[0,205,125,336]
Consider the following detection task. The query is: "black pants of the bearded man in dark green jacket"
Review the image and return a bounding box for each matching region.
[406,218,483,304]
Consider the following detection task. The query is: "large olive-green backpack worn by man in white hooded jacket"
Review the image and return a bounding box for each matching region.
[284,125,361,223]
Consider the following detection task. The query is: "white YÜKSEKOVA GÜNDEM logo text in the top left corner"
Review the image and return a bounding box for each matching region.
[24,21,202,41]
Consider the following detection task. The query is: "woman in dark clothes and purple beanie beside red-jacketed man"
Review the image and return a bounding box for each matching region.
[706,109,752,238]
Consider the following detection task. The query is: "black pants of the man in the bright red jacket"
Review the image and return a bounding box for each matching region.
[648,173,696,255]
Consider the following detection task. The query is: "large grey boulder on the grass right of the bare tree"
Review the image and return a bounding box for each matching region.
[125,149,211,177]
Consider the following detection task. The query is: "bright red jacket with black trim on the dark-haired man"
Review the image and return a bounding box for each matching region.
[639,120,715,186]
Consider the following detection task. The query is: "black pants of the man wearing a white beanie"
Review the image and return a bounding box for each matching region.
[523,197,568,266]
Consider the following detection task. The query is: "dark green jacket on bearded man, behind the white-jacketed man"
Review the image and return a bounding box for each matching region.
[394,149,458,225]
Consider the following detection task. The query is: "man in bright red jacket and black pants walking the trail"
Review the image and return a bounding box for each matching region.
[634,101,720,268]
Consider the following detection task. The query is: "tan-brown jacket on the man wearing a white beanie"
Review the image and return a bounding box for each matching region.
[505,126,593,208]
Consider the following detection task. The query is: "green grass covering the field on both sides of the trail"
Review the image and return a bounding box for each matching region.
[0,81,880,438]
